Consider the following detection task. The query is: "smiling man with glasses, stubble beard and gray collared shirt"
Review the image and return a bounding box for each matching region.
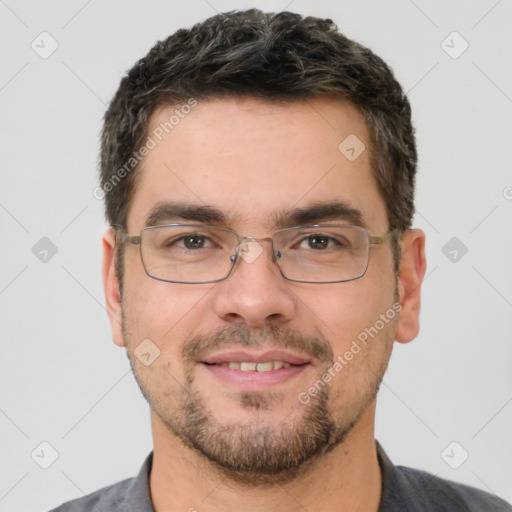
[50,10,512,512]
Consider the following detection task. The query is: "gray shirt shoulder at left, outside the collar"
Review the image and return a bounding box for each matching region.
[50,478,134,512]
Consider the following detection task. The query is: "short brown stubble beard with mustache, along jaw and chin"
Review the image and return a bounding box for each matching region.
[123,324,394,487]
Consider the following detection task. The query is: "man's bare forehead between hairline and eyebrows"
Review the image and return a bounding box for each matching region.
[128,98,387,232]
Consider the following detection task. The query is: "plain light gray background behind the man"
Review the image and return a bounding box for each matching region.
[0,0,512,512]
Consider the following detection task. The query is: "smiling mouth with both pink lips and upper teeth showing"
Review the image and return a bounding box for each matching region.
[200,350,313,391]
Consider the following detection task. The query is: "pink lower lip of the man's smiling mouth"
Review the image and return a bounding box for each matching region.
[201,363,311,389]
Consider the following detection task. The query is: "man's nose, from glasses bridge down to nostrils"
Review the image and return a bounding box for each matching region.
[210,239,297,328]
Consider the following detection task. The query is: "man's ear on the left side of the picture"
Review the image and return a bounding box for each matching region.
[102,228,125,347]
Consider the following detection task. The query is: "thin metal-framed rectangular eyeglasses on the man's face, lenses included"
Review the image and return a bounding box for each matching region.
[120,224,396,284]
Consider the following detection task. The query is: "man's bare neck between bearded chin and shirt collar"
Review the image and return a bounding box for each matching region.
[150,402,381,512]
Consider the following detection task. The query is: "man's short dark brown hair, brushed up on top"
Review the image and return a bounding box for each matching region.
[100,9,417,288]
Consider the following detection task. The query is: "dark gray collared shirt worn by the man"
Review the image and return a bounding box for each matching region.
[50,442,512,512]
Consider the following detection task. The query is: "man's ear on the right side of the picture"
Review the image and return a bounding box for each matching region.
[395,229,427,343]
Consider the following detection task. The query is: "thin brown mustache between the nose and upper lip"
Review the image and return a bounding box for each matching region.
[182,324,334,364]
